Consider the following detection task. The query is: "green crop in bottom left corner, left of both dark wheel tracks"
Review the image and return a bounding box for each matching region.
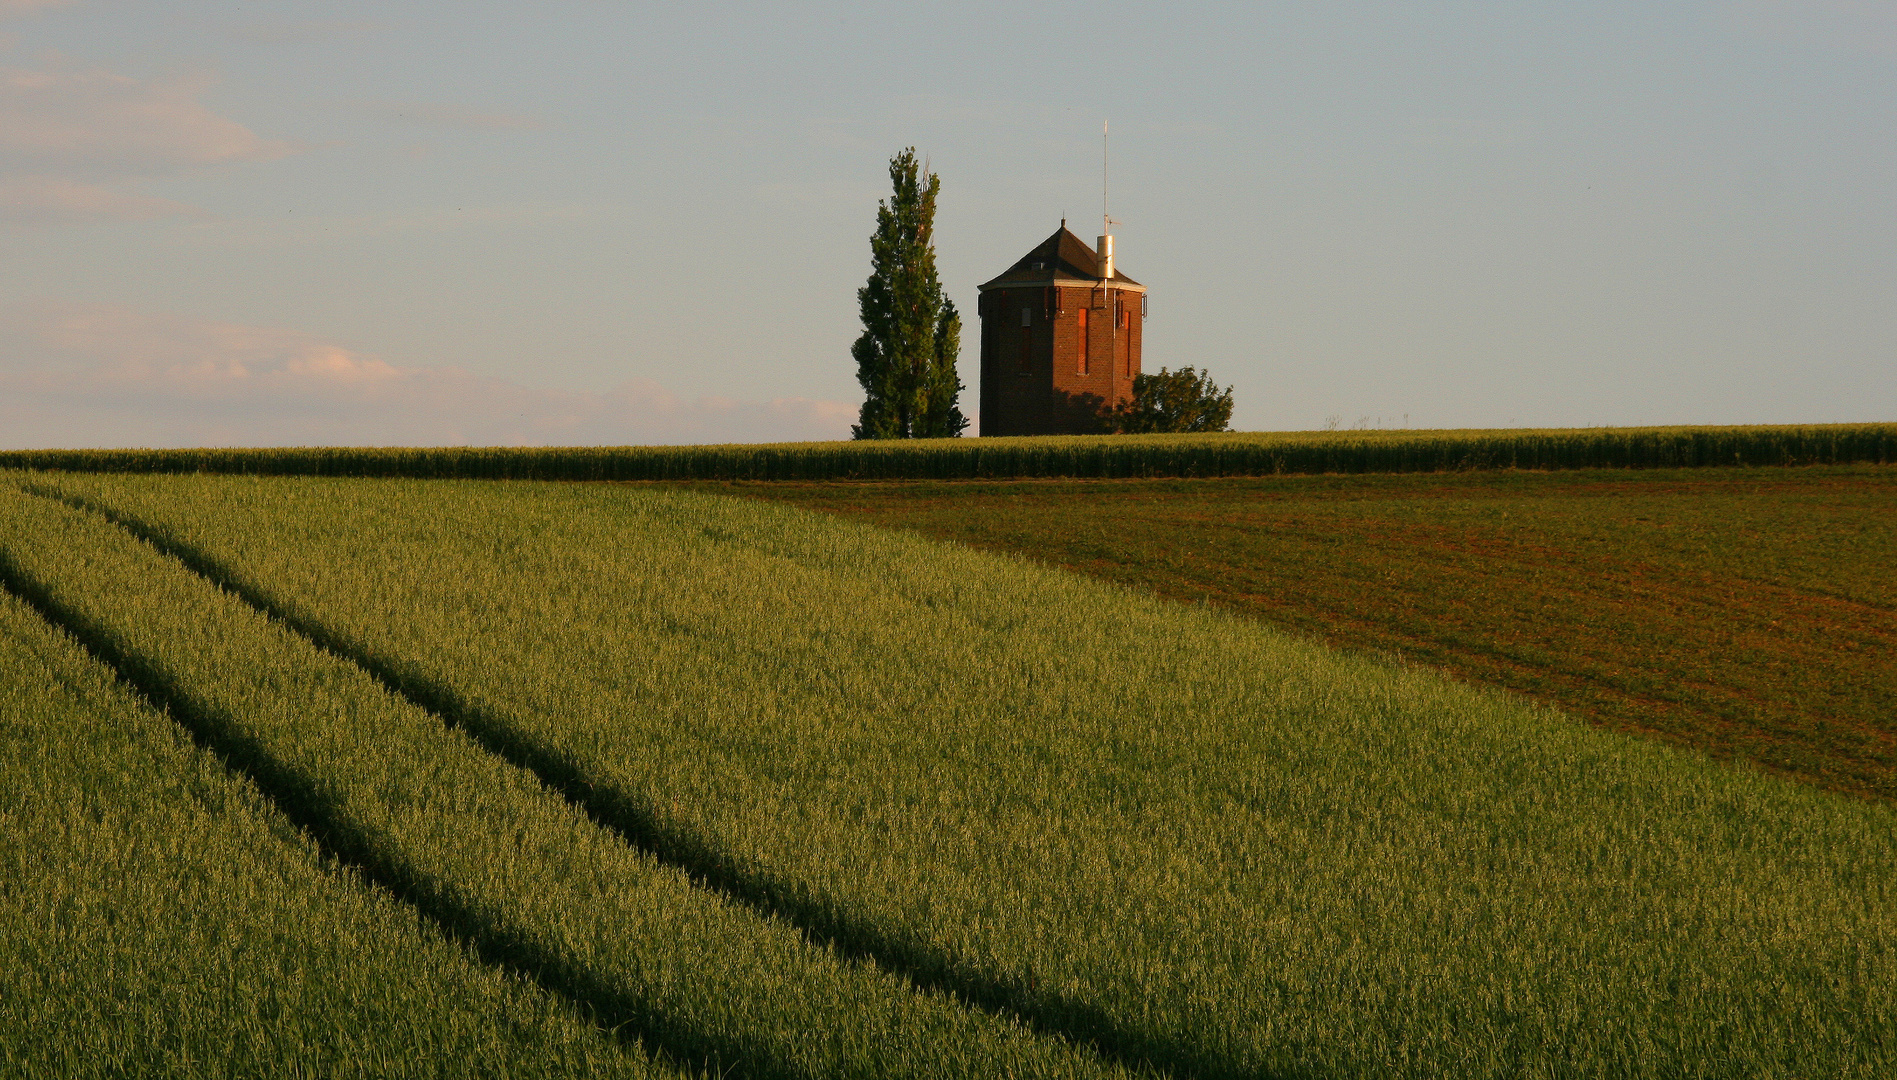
[0,592,673,1080]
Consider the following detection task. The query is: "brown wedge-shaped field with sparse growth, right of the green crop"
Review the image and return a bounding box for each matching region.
[725,465,1897,799]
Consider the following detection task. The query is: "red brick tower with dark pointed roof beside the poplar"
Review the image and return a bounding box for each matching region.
[981,222,1146,435]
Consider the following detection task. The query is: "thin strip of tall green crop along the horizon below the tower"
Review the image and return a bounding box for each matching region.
[0,423,1897,480]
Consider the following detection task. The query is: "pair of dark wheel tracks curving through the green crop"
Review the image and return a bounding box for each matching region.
[14,486,1282,1080]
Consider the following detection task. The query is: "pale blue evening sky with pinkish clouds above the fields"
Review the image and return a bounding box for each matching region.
[0,0,1897,448]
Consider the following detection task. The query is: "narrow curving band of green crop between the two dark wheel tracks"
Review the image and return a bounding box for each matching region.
[0,484,1114,1076]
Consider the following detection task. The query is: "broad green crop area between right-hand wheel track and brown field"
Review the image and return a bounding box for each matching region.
[27,475,1897,1078]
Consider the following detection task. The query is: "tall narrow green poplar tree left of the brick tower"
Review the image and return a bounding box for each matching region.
[850,146,967,438]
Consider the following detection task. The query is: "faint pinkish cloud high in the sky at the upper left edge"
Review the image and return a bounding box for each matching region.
[0,66,296,224]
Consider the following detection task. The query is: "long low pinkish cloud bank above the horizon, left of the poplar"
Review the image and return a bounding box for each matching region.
[0,304,856,448]
